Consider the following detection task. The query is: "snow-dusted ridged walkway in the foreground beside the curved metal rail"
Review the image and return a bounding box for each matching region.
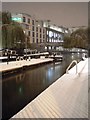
[13,59,90,118]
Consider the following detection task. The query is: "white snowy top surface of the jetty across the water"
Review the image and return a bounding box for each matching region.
[0,58,53,72]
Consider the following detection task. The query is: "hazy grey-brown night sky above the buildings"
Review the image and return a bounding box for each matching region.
[2,2,88,27]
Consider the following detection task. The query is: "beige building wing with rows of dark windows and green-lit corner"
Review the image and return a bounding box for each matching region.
[12,13,45,43]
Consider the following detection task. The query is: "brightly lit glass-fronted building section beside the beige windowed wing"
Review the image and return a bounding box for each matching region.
[43,20,68,52]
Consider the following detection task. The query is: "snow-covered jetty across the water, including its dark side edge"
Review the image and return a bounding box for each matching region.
[0,58,53,75]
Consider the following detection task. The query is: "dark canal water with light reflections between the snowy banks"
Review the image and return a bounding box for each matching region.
[2,53,82,119]
